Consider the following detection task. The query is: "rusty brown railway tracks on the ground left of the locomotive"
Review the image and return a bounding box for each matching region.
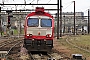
[0,39,23,59]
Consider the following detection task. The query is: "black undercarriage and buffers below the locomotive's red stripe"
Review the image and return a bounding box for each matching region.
[24,39,53,52]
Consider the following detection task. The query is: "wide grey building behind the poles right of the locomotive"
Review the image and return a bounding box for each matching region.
[55,12,87,33]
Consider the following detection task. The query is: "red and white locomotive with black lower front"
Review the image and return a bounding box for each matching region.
[24,7,54,51]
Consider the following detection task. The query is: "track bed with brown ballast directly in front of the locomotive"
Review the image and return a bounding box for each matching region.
[30,52,70,60]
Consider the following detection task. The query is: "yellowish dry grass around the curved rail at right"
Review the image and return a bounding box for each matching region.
[59,35,90,57]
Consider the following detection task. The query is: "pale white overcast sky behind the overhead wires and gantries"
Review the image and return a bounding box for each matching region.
[0,0,90,14]
